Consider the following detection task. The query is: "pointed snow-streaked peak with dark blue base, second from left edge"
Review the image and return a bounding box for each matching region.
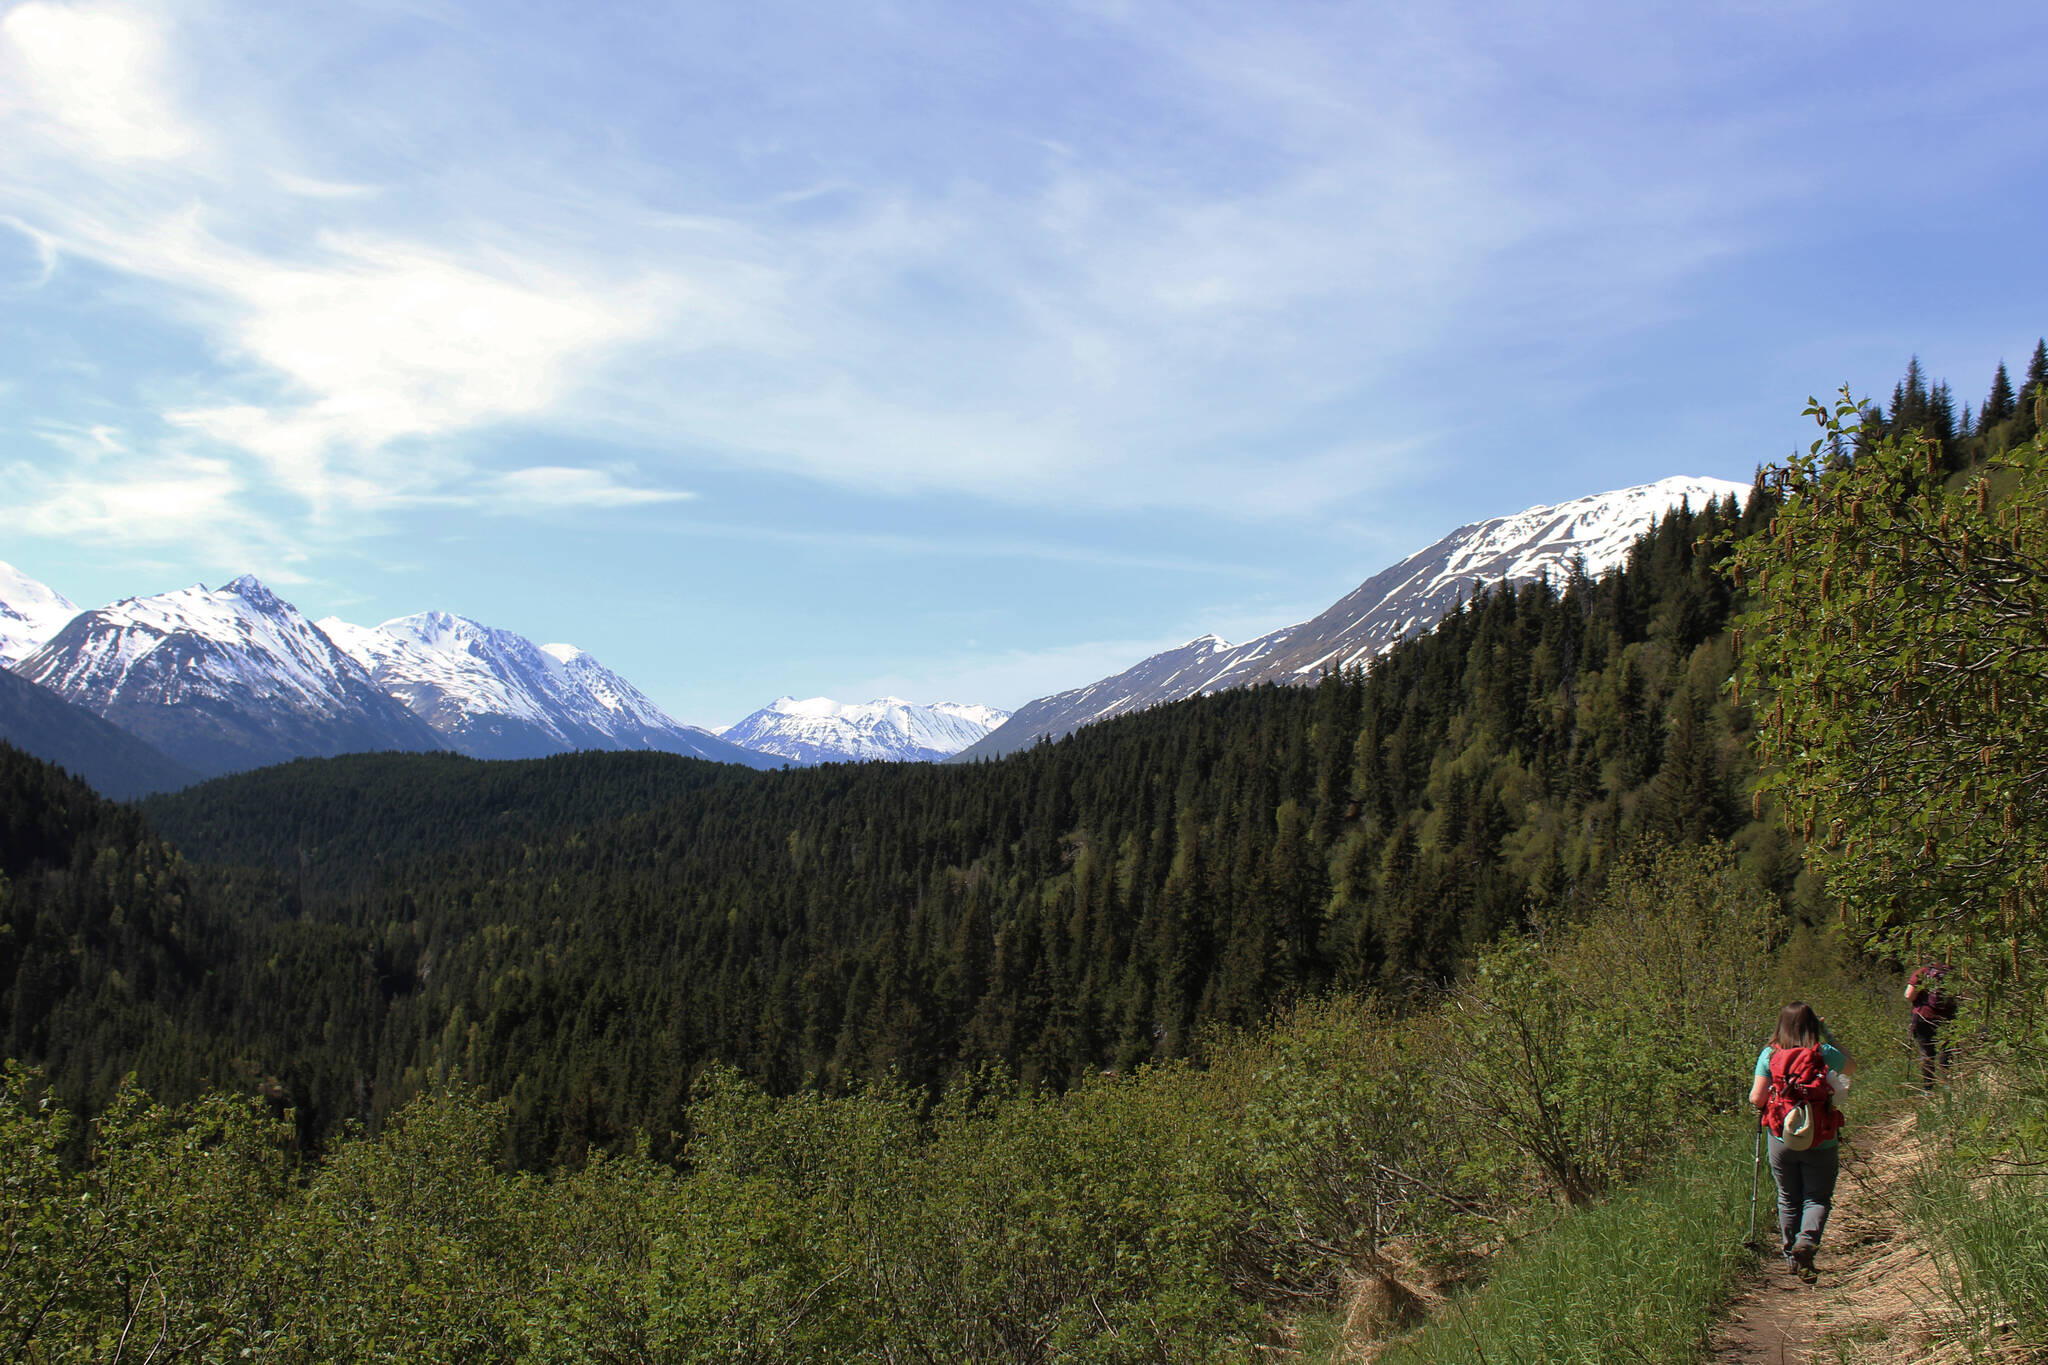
[16,575,444,776]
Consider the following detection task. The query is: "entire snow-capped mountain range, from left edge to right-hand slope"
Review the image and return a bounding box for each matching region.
[0,477,1747,796]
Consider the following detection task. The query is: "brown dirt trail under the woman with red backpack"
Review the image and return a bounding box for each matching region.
[1708,1109,1966,1365]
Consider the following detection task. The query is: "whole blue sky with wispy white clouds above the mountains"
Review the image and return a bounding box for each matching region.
[0,0,2048,724]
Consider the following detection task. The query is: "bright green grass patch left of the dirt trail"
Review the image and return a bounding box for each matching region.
[1378,1128,1774,1365]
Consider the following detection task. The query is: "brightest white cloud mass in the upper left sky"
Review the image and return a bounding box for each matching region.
[0,4,709,526]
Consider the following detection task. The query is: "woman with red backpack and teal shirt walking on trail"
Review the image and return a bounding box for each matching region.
[1749,1001,1855,1281]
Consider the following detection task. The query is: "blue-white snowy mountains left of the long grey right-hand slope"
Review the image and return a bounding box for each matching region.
[0,565,1008,777]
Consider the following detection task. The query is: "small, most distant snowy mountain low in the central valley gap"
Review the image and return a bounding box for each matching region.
[723,696,1010,763]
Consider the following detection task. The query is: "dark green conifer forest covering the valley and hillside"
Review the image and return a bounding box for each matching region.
[0,491,1796,1164]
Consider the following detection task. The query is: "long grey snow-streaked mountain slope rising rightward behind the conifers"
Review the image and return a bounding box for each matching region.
[958,475,1749,759]
